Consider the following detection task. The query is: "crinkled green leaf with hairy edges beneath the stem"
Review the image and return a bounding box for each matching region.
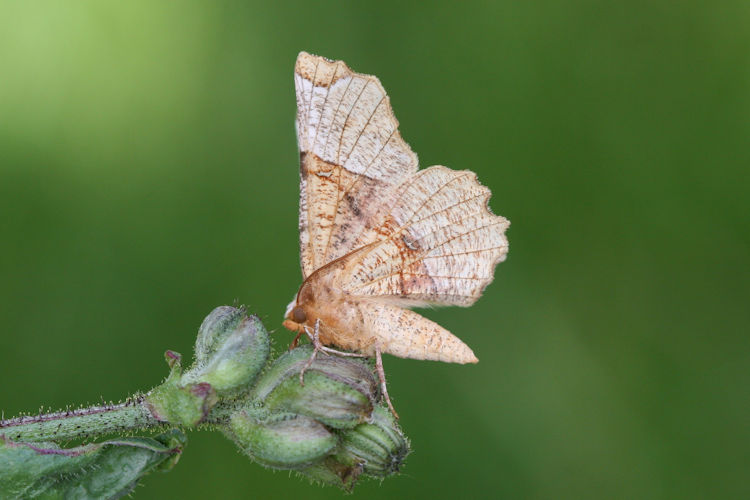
[0,429,187,499]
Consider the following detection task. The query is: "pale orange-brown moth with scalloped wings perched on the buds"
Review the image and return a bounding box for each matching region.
[284,52,510,415]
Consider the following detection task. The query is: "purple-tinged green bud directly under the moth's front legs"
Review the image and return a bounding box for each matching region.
[252,346,378,428]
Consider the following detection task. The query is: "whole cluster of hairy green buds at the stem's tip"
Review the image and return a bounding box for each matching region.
[146,307,409,489]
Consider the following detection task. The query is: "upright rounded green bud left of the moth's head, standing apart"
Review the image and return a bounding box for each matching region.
[182,306,270,396]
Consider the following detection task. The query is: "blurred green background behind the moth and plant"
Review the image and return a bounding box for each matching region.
[0,0,750,499]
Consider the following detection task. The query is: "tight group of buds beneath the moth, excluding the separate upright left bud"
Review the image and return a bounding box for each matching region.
[227,346,409,489]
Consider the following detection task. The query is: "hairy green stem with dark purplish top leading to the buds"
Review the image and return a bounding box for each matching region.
[0,396,167,442]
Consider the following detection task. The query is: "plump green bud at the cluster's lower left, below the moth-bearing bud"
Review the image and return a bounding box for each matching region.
[229,411,337,469]
